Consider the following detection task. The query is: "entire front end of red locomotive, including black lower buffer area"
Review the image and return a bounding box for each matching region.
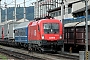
[40,20,63,49]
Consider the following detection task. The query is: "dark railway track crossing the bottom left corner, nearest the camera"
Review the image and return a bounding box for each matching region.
[0,48,43,60]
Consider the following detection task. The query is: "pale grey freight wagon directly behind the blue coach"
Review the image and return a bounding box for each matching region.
[3,20,20,40]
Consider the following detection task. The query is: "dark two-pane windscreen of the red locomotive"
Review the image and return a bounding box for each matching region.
[44,23,59,34]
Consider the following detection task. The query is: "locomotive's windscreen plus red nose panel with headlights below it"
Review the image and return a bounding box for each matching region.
[42,23,62,41]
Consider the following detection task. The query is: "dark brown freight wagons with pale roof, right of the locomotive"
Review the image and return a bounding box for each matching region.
[64,21,90,51]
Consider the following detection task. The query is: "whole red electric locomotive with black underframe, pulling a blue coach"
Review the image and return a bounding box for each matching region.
[28,18,64,51]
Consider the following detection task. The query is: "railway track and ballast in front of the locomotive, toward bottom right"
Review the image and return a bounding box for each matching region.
[33,52,79,60]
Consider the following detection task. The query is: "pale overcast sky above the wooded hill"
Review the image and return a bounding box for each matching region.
[1,0,36,7]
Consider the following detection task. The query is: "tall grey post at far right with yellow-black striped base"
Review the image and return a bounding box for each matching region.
[81,0,88,60]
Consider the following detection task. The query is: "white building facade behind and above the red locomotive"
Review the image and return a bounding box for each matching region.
[34,0,90,19]
